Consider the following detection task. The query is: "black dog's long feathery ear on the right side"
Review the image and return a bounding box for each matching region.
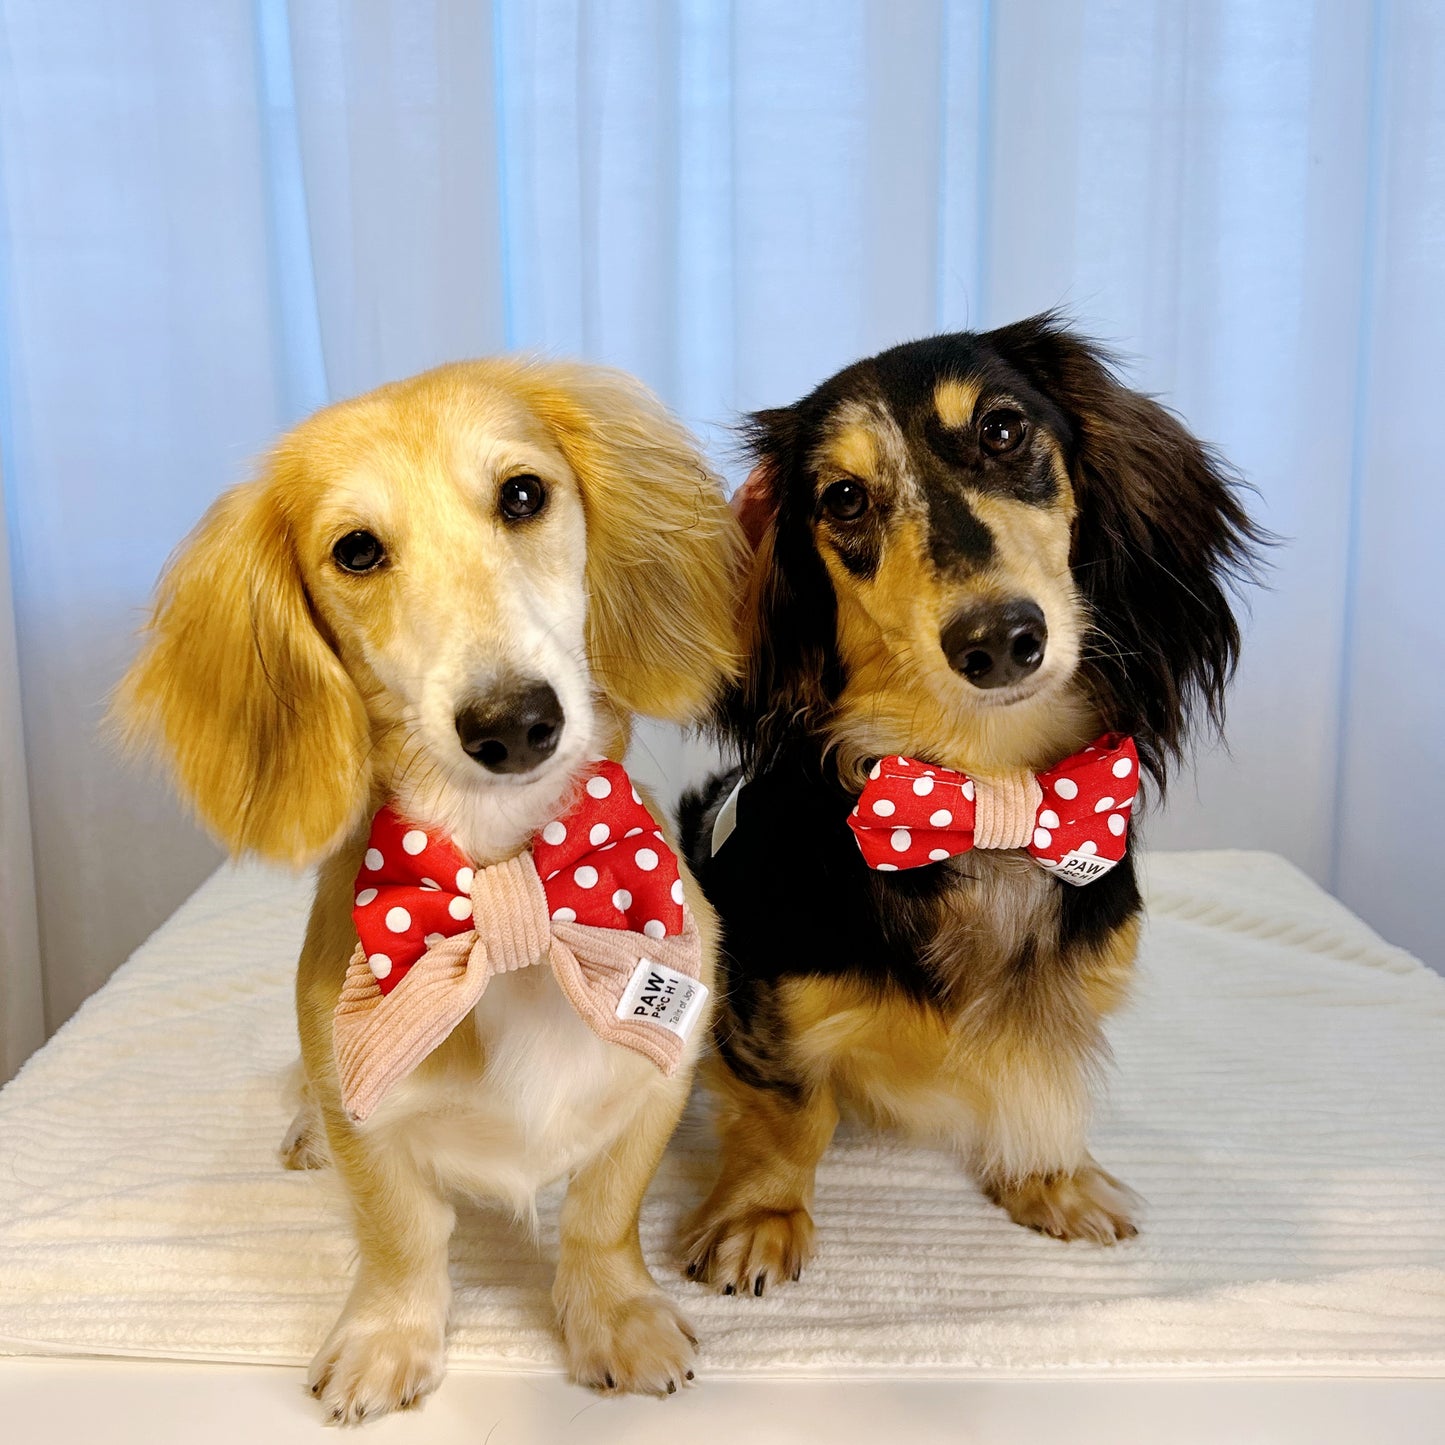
[994,315,1266,788]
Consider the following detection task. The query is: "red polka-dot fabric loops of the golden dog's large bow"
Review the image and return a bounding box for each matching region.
[353,760,683,994]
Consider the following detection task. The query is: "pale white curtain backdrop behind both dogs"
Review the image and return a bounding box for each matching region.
[0,0,1445,1077]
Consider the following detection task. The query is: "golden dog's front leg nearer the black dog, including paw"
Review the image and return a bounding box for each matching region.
[552,1078,698,1394]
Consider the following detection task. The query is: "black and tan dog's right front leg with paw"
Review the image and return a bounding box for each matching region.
[971,1040,1139,1244]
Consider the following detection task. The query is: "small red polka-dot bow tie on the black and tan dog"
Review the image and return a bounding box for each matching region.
[848,733,1139,883]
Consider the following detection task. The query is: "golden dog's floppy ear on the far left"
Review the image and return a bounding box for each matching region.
[111,460,370,864]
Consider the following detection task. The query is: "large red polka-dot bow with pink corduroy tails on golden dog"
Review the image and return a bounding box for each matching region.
[334,759,708,1120]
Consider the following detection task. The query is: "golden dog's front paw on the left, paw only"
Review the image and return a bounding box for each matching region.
[306,1316,447,1425]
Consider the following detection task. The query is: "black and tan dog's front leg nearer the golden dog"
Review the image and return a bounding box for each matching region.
[683,1062,838,1295]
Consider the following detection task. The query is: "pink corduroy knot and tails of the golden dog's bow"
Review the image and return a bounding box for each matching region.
[334,853,702,1123]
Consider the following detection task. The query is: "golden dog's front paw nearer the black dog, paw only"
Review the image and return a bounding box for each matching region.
[562,1293,698,1394]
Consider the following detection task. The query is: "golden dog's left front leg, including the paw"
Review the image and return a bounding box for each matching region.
[308,1117,455,1425]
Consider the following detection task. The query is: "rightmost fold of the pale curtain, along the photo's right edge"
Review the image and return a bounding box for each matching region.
[1329,0,1445,947]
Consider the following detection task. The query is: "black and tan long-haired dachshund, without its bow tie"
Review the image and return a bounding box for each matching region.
[683,316,1261,1293]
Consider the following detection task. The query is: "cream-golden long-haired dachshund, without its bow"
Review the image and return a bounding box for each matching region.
[116,360,741,1422]
